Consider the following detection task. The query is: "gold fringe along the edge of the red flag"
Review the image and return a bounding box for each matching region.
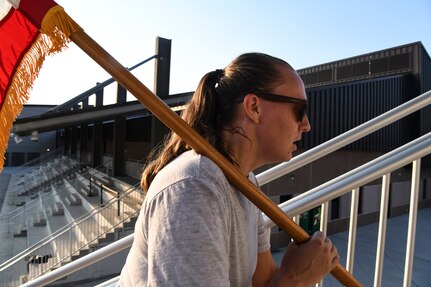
[0,5,82,172]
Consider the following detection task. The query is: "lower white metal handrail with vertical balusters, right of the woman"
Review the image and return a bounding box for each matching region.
[280,143,431,287]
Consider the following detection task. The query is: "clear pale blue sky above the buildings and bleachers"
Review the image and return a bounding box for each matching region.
[28,0,431,104]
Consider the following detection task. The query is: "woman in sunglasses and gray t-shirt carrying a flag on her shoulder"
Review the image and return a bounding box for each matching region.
[119,53,338,286]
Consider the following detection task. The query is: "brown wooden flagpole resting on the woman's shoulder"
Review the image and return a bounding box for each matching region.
[69,31,362,286]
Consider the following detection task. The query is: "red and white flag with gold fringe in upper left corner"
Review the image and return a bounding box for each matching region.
[0,0,81,171]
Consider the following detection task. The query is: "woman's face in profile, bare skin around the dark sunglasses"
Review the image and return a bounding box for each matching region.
[256,68,311,164]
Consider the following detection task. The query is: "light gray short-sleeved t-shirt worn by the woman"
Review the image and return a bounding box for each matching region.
[119,151,270,287]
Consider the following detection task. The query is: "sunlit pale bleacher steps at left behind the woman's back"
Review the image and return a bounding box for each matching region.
[0,158,144,286]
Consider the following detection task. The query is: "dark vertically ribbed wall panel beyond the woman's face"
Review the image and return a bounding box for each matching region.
[299,74,420,150]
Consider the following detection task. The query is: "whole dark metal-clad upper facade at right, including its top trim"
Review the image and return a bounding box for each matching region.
[298,42,431,154]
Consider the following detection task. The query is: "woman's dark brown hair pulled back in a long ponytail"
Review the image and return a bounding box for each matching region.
[141,53,293,191]
